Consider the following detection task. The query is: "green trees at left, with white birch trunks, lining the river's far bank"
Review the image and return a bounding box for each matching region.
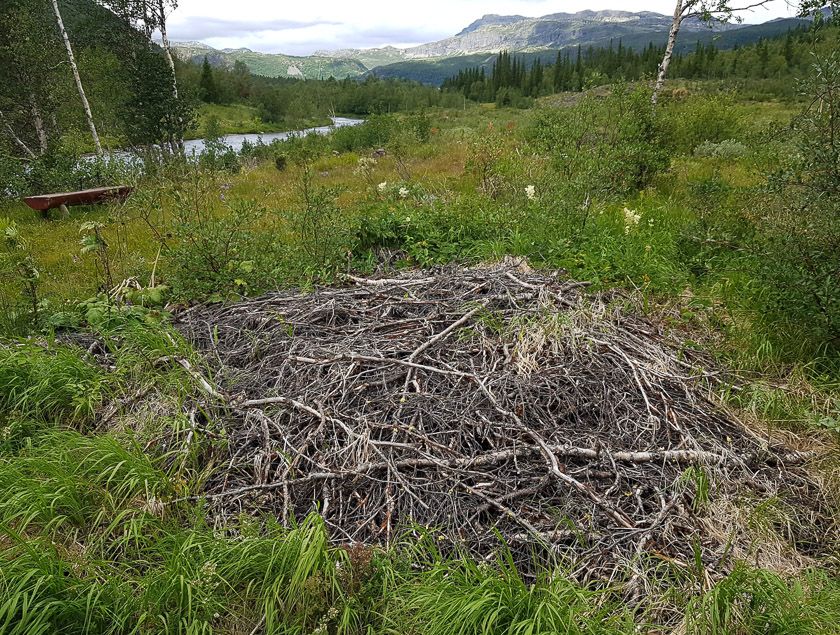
[0,0,458,162]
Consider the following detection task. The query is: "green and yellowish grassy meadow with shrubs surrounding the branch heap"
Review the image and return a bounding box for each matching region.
[0,84,840,635]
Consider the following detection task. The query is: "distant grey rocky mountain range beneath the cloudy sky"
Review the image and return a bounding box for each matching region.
[174,11,820,84]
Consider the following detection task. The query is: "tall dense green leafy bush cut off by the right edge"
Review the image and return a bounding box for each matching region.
[758,54,840,342]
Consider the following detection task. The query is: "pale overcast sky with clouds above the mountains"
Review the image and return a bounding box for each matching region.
[164,0,795,55]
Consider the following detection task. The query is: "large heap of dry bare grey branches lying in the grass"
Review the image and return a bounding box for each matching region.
[177,263,824,578]
